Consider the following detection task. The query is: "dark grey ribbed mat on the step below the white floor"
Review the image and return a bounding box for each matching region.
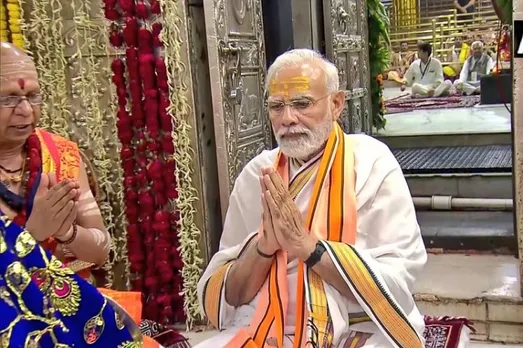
[392,145,512,174]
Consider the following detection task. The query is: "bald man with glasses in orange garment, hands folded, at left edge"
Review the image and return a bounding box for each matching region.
[0,42,111,279]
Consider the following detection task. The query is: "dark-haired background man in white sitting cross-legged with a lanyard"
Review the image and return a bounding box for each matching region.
[403,42,452,97]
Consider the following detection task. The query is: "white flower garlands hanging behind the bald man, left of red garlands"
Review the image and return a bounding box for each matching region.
[22,0,129,289]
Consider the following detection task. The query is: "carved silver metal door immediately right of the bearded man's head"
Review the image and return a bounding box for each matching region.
[323,0,372,133]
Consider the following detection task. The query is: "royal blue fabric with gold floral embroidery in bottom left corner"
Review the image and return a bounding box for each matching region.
[0,211,143,348]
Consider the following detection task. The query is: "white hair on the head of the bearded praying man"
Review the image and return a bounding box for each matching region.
[265,48,340,93]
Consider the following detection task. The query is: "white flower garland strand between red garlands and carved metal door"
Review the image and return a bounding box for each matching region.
[160,0,203,330]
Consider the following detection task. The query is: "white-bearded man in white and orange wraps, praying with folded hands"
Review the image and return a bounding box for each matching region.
[197,49,427,348]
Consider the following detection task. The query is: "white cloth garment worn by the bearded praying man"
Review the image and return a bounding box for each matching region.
[197,135,427,348]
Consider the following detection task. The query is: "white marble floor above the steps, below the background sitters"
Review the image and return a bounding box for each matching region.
[378,87,511,136]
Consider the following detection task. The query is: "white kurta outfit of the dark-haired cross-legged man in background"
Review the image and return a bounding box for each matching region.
[405,57,452,97]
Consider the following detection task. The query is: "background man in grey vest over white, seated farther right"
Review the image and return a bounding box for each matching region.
[454,41,495,95]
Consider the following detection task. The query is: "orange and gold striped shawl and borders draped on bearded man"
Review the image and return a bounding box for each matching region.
[204,124,423,348]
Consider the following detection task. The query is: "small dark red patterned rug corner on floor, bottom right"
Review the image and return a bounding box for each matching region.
[423,316,475,348]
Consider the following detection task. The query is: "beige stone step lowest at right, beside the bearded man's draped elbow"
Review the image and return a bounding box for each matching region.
[415,254,523,343]
